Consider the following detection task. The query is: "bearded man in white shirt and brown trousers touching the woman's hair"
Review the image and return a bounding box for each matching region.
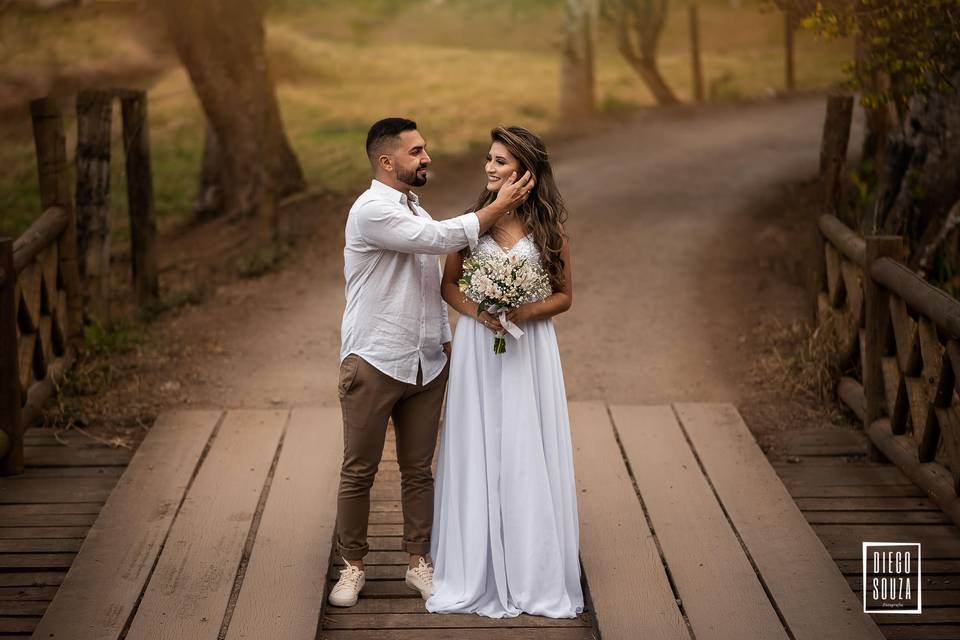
[329,118,533,607]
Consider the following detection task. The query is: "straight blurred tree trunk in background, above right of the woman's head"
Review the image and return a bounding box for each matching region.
[560,0,597,122]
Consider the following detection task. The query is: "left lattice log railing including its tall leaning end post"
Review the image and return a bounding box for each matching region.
[0,99,82,475]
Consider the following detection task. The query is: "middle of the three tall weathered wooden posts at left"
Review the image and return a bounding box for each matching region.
[76,91,113,326]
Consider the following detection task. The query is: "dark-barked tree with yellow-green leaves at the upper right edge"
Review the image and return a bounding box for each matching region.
[803,0,960,282]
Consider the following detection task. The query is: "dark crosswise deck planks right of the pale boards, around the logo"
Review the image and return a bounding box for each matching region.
[773,429,960,640]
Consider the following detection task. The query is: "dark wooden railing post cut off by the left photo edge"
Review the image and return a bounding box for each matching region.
[0,238,23,475]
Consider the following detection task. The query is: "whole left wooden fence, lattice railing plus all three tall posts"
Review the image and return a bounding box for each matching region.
[0,91,158,475]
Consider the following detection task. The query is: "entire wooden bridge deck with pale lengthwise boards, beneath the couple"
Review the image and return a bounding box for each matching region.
[0,403,928,640]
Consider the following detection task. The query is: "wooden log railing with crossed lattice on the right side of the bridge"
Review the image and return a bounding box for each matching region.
[817,214,960,522]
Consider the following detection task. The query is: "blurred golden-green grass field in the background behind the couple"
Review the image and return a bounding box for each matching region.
[0,0,850,241]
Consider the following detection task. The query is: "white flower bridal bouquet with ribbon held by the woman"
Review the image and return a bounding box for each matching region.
[458,254,551,354]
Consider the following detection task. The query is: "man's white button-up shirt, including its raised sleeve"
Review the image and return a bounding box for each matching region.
[340,180,480,384]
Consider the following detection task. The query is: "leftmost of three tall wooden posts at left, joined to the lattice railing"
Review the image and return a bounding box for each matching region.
[30,98,83,347]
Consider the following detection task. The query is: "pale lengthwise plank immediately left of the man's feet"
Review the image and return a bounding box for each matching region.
[226,409,343,640]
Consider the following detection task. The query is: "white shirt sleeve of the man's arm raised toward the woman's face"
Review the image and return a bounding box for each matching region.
[353,201,480,255]
